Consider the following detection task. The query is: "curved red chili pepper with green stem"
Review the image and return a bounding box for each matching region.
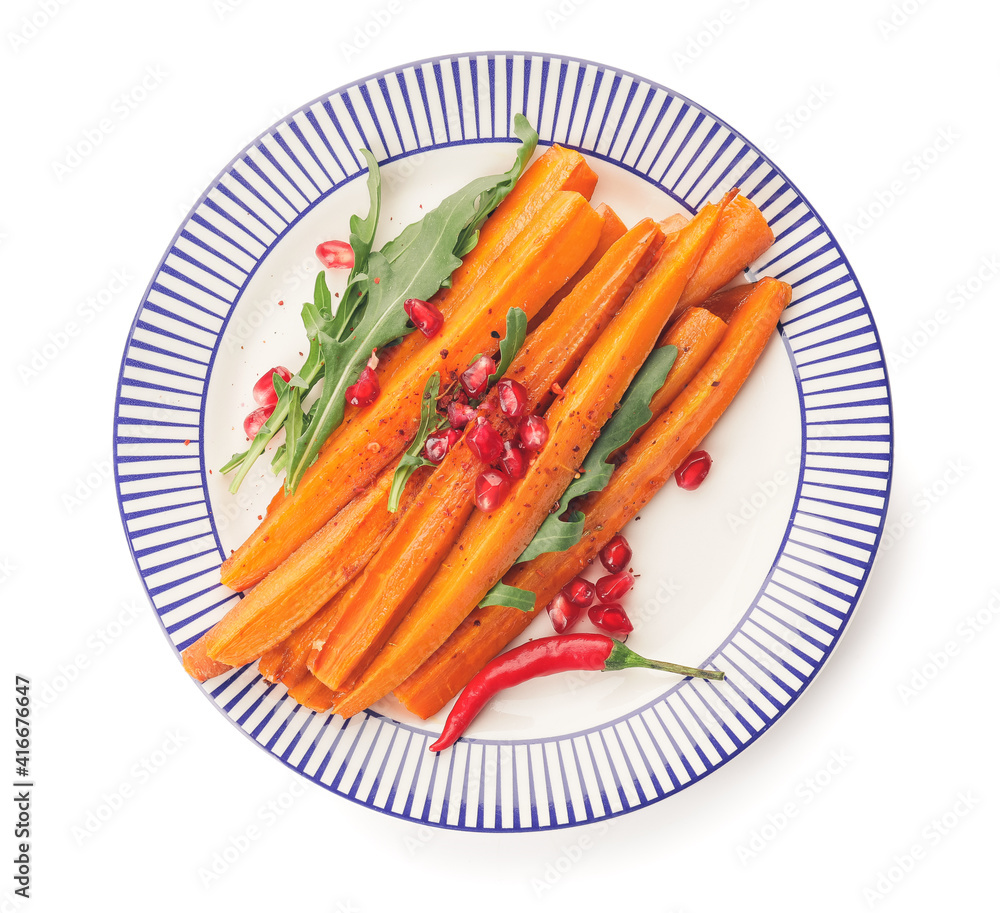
[430,634,725,751]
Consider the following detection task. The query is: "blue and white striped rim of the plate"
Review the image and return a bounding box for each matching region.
[115,53,892,830]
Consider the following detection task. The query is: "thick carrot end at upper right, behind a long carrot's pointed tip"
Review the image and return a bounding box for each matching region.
[677,196,774,313]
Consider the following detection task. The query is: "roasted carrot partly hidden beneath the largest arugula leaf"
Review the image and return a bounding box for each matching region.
[262,145,597,516]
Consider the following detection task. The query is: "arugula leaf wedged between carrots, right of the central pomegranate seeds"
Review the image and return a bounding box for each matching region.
[479,346,677,611]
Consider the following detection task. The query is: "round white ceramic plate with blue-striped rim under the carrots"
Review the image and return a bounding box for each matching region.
[115,53,892,830]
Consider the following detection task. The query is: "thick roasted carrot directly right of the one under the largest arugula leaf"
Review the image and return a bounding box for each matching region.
[221,191,601,589]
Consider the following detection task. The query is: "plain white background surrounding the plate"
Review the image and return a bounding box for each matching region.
[0,0,1000,913]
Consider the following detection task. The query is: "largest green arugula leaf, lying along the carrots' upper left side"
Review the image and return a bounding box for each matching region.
[285,118,538,492]
